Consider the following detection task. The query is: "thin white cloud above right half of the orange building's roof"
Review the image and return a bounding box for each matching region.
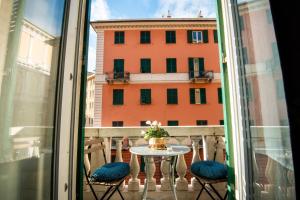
[155,0,216,18]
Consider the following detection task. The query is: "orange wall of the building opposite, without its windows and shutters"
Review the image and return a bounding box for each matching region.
[95,19,223,126]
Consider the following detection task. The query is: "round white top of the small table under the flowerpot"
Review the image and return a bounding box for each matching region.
[130,144,191,156]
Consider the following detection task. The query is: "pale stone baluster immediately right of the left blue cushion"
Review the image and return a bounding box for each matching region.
[128,138,140,191]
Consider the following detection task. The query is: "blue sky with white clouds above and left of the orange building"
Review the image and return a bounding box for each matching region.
[88,0,216,71]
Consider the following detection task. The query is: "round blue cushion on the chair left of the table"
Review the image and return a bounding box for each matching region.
[91,162,130,182]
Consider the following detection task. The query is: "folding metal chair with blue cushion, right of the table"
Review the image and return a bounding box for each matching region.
[190,135,228,200]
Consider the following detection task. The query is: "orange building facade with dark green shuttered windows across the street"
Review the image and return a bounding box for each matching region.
[92,18,223,127]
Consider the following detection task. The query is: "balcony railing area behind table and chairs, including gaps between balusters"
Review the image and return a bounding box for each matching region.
[84,126,226,200]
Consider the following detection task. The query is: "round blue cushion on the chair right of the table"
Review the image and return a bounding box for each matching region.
[191,160,227,180]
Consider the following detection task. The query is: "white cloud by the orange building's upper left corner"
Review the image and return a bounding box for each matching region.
[91,0,110,21]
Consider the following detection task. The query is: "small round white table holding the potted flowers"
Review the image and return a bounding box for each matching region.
[130,144,191,200]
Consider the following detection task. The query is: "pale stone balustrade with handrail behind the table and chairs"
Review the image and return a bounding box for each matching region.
[84,126,224,197]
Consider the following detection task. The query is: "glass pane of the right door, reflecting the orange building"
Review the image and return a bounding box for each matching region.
[235,0,295,199]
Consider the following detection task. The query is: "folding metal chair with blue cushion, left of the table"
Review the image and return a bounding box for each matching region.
[83,139,130,200]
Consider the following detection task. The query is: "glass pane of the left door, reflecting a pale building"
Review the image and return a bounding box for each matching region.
[0,0,65,199]
